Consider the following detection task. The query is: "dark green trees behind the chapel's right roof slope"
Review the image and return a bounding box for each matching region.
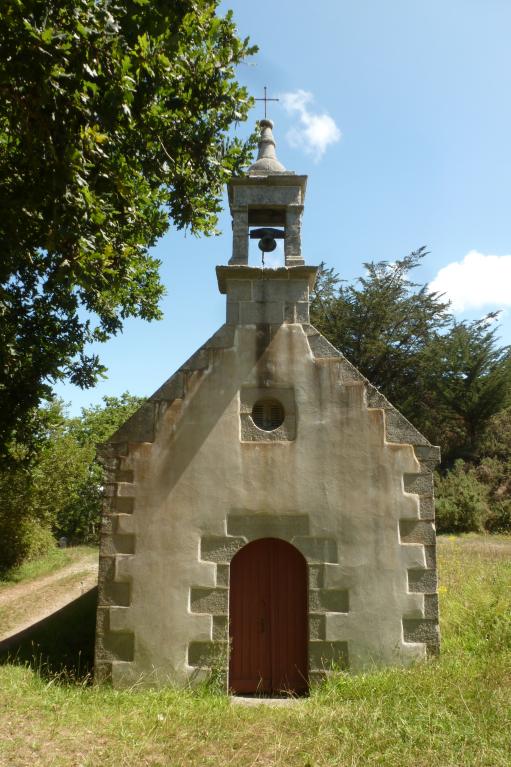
[311,248,511,466]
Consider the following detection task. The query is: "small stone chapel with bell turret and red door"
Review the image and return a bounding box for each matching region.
[95,120,439,695]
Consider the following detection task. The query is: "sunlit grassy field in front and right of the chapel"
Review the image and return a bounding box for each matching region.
[0,536,511,767]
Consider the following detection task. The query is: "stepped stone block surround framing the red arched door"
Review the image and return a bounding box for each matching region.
[188,511,349,687]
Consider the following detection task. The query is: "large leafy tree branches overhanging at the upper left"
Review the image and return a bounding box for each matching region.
[0,0,255,456]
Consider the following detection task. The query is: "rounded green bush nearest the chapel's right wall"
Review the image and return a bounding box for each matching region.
[435,460,490,532]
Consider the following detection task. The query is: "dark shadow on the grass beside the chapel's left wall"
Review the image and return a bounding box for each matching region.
[0,587,98,681]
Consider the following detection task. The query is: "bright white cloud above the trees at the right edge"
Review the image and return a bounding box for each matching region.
[429,250,511,313]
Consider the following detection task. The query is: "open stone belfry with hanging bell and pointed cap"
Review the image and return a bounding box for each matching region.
[227,119,307,266]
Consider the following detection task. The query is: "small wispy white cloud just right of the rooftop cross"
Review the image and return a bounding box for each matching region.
[280,90,342,162]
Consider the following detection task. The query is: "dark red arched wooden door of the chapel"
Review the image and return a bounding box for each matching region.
[229,538,308,693]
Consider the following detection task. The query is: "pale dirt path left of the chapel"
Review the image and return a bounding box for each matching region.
[0,555,98,641]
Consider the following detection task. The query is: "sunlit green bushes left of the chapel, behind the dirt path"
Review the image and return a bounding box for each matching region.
[0,392,143,572]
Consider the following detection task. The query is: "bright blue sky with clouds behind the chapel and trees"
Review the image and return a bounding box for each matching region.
[56,0,511,413]
